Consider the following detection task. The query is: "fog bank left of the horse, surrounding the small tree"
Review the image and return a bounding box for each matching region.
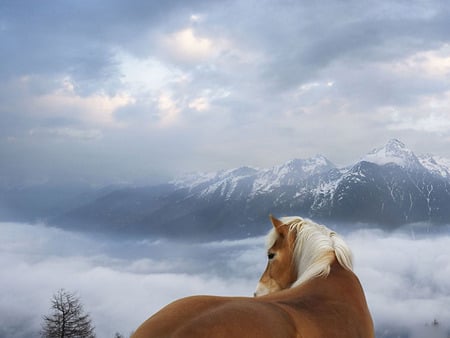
[0,223,264,337]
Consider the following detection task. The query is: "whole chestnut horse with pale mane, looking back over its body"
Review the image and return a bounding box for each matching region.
[132,217,374,338]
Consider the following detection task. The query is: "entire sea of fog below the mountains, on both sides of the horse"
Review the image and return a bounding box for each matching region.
[0,223,450,338]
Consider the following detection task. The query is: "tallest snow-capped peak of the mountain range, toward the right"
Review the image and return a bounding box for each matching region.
[362,139,421,169]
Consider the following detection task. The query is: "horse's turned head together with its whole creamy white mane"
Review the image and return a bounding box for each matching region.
[255,216,352,296]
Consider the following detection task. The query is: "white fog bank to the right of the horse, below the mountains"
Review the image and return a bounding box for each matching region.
[348,230,450,331]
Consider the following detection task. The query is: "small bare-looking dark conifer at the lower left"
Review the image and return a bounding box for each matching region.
[41,289,95,338]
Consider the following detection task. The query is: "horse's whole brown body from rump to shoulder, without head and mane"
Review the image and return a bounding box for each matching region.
[133,265,374,338]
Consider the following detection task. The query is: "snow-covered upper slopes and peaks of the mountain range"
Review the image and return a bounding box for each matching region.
[171,139,450,205]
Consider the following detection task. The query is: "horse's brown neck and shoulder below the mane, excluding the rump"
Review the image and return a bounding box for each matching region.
[266,264,374,338]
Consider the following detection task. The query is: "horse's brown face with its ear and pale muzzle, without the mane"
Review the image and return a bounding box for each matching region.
[255,215,298,297]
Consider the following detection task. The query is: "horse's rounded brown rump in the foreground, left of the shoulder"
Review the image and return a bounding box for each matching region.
[132,296,297,338]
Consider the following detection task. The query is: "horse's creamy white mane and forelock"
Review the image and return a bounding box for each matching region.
[266,216,353,287]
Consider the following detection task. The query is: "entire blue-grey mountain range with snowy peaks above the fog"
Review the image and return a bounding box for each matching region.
[44,139,450,240]
